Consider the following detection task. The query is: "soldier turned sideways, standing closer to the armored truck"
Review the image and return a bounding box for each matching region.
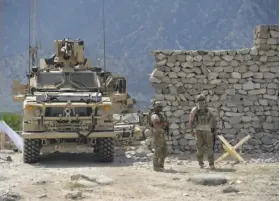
[148,102,167,171]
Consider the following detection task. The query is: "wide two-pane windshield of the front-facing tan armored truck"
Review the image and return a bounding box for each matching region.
[37,72,100,89]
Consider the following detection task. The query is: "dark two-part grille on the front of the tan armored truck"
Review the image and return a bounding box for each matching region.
[45,107,92,117]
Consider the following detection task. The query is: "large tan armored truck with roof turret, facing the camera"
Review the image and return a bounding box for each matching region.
[13,38,130,163]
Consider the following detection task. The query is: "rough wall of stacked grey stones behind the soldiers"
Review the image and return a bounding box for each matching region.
[150,25,279,153]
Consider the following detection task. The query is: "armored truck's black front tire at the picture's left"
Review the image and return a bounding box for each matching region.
[23,139,41,163]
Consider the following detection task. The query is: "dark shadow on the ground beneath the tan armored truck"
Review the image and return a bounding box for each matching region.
[32,153,135,168]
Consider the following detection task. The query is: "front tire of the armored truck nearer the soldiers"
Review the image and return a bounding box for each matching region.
[95,137,115,163]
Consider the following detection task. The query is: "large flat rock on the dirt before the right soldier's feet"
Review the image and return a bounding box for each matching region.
[189,174,228,186]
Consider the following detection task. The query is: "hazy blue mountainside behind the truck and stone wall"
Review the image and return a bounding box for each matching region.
[0,0,279,111]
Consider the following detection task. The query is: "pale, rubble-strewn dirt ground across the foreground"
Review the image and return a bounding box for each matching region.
[0,148,279,201]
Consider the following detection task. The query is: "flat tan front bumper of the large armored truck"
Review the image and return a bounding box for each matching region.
[21,130,117,139]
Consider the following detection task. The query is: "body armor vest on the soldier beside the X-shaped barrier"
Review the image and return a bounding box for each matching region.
[195,109,212,132]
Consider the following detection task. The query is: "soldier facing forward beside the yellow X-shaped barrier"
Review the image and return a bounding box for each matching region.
[189,94,216,169]
